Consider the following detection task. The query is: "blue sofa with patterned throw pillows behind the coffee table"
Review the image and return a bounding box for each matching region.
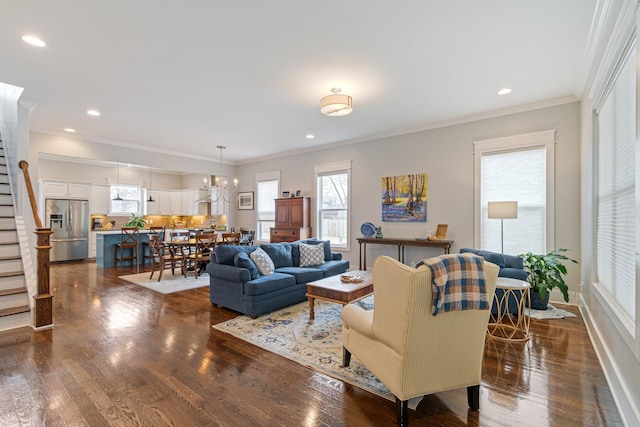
[207,239,349,318]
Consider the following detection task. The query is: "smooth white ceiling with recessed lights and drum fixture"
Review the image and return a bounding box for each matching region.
[0,0,596,163]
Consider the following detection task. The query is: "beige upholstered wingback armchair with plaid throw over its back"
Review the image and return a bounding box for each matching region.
[342,256,498,426]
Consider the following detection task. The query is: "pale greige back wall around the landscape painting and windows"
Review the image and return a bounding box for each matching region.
[237,102,580,294]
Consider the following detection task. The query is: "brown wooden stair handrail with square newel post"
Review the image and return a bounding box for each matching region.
[18,160,53,329]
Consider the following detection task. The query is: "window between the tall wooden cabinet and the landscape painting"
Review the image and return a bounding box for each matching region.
[315,162,351,249]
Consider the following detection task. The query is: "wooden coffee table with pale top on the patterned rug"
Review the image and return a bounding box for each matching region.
[306,270,373,320]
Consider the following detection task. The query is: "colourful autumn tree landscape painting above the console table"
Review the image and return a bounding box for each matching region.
[381,173,427,222]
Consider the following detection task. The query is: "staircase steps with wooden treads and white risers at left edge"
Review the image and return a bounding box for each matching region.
[0,147,31,331]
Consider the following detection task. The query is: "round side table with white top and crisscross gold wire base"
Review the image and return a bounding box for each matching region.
[487,277,531,342]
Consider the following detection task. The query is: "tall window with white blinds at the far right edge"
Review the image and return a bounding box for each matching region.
[595,44,636,328]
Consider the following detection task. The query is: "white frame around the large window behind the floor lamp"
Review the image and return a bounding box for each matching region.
[473,129,556,252]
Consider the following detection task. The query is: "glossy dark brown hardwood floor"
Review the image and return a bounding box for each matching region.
[0,262,622,427]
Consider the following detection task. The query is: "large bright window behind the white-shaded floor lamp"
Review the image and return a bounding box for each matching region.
[474,131,555,255]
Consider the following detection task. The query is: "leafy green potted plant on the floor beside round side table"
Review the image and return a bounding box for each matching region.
[518,248,578,310]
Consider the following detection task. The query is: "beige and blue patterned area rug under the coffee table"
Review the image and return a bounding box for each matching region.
[211,297,422,409]
